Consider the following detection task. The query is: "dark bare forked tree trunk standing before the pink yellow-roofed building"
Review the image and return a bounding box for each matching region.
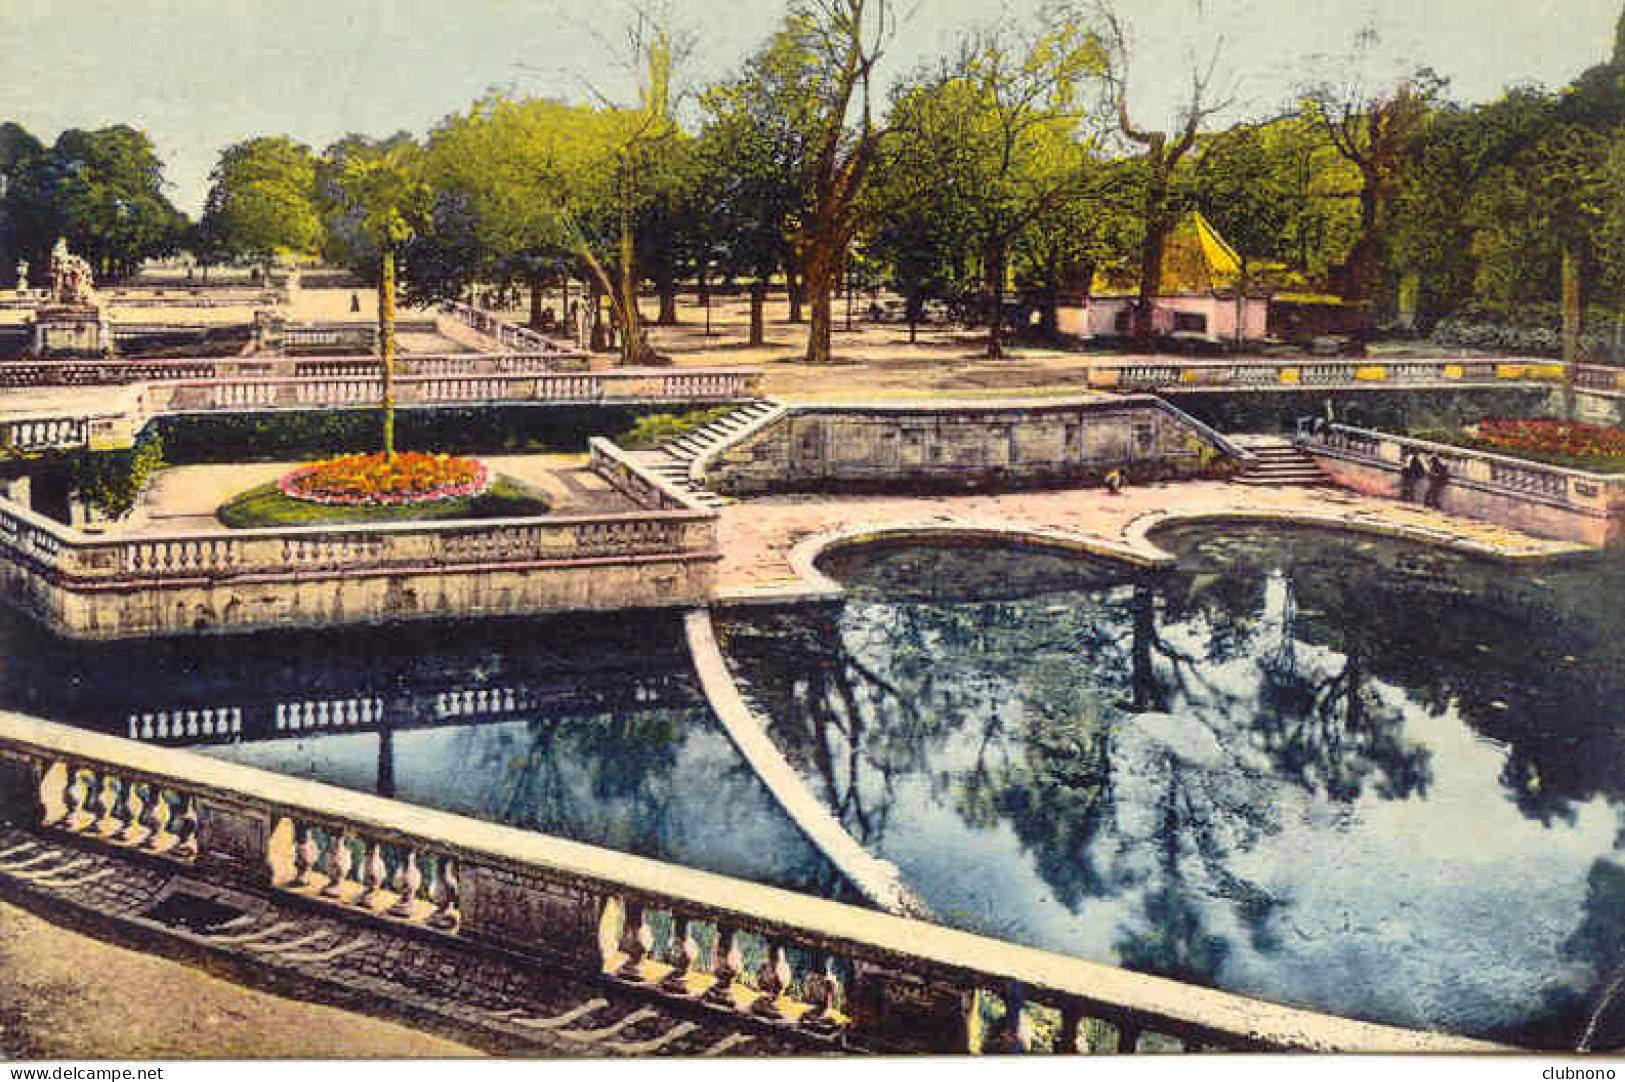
[1095,0,1230,341]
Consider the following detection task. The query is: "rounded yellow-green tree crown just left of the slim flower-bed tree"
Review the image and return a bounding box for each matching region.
[202,135,322,271]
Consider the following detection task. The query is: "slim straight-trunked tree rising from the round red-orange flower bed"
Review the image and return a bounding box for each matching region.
[320,143,429,460]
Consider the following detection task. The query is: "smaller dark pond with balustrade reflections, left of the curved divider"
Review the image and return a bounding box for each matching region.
[0,612,853,900]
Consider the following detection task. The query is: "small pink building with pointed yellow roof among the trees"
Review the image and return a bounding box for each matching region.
[1058,211,1269,341]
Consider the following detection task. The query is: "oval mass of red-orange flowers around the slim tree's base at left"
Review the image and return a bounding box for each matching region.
[276,452,491,507]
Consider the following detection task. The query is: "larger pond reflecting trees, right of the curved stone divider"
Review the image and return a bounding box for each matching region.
[722,525,1625,1048]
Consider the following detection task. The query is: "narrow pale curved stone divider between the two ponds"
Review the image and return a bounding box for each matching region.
[683,609,933,920]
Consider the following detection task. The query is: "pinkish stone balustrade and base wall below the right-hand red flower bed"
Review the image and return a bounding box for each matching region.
[1297,419,1625,544]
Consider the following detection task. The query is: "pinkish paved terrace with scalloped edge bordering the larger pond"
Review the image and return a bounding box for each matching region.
[717,481,1591,599]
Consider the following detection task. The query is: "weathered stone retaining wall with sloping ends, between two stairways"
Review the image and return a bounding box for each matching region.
[696,395,1246,494]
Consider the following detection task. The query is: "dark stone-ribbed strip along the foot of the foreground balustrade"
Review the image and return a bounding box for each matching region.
[0,825,850,1056]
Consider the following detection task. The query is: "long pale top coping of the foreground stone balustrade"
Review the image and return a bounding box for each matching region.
[0,712,1515,1053]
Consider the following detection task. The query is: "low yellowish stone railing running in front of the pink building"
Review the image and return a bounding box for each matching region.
[1089,357,1563,390]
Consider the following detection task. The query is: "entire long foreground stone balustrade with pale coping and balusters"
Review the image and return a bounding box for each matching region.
[0,713,1503,1053]
